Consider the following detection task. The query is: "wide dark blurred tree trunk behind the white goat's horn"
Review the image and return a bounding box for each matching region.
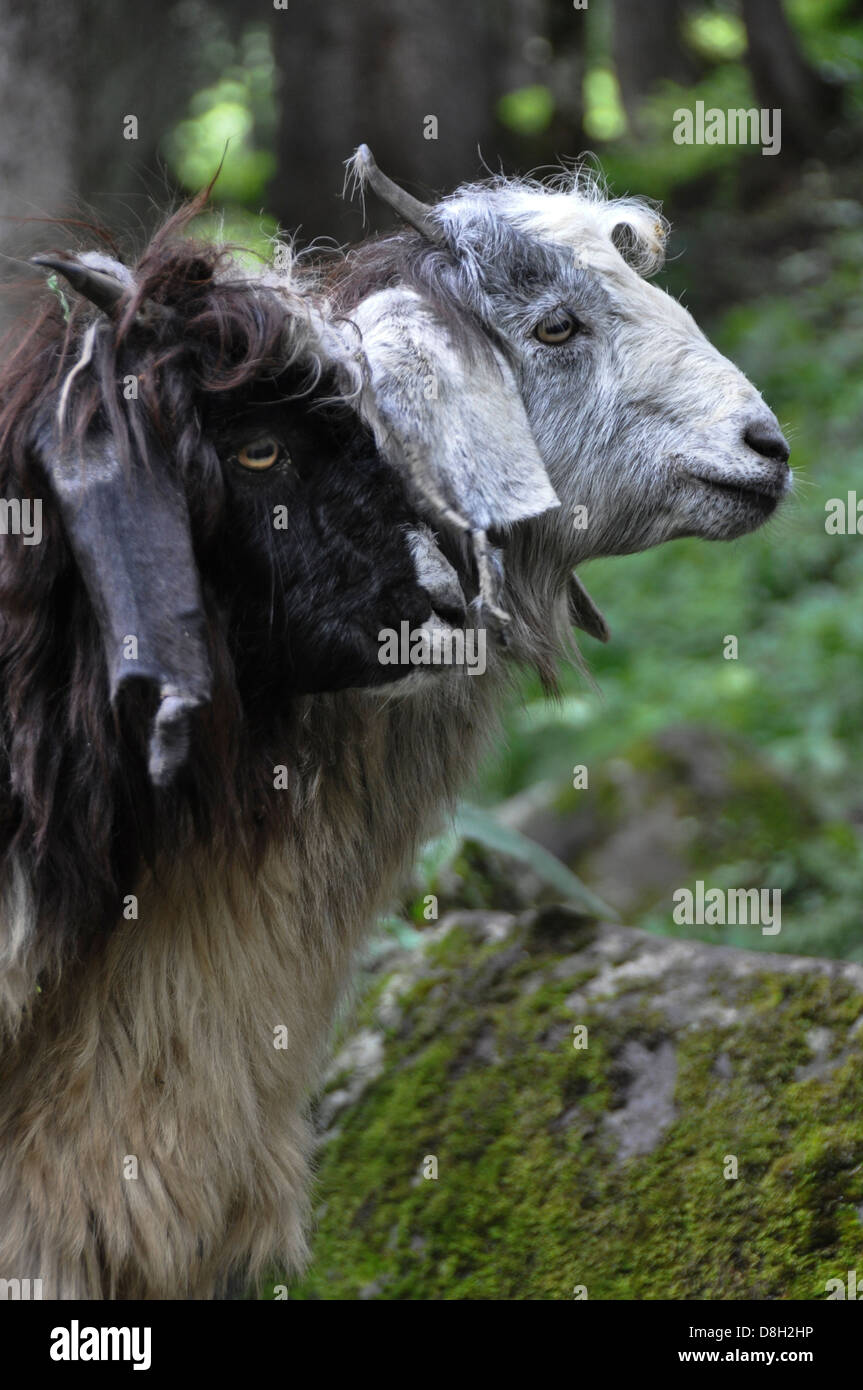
[270,0,507,240]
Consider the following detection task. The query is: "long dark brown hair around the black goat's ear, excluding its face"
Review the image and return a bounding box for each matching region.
[0,195,321,973]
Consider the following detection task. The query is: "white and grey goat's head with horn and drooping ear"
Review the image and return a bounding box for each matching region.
[346,146,791,581]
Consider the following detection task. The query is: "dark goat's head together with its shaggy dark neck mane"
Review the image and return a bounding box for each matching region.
[0,211,464,961]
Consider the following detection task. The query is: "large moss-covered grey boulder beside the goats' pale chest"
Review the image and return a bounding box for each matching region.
[280,908,863,1300]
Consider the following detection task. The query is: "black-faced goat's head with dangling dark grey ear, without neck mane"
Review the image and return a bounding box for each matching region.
[18,223,457,783]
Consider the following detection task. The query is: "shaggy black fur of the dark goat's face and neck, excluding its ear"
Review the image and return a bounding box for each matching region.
[0,209,444,962]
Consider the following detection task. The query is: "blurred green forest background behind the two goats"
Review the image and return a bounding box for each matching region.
[0,0,863,959]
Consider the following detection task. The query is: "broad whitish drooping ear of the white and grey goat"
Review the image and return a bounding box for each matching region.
[353,289,560,531]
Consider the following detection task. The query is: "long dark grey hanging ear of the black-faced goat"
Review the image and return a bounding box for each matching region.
[39,431,210,787]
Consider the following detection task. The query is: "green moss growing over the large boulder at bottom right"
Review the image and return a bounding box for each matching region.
[284,927,863,1300]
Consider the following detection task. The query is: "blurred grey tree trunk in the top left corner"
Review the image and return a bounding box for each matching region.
[0,0,223,262]
